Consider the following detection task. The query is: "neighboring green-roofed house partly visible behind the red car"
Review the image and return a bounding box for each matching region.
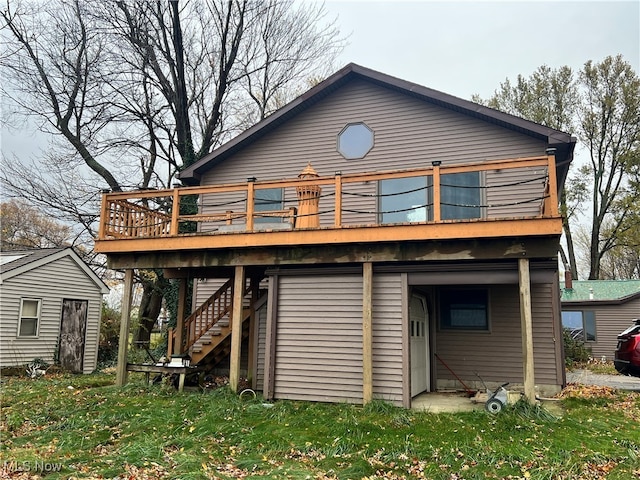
[560,280,640,360]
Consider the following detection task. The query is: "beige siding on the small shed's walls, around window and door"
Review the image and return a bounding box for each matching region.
[0,257,102,373]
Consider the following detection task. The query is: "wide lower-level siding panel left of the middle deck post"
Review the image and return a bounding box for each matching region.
[274,275,362,403]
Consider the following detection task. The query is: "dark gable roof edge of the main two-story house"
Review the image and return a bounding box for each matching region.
[178,63,576,188]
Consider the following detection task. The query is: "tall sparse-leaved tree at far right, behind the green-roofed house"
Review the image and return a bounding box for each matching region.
[580,56,640,280]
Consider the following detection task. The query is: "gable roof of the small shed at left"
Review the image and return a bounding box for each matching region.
[0,247,109,294]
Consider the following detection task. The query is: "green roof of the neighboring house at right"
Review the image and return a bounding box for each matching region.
[560,280,640,303]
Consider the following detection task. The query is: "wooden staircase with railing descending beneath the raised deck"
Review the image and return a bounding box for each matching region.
[167,279,267,365]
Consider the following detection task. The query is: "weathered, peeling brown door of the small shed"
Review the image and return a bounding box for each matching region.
[58,299,89,373]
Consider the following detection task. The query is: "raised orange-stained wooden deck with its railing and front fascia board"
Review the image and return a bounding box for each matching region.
[95,155,562,256]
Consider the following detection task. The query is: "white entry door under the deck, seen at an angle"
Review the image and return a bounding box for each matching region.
[409,294,430,397]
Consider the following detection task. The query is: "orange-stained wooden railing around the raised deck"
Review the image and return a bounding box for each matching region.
[97,155,558,240]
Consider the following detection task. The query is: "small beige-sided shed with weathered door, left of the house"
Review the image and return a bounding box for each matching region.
[0,248,109,373]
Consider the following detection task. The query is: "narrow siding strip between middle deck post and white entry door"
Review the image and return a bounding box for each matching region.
[373,272,403,405]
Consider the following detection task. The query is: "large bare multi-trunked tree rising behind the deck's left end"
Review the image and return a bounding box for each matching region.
[0,0,342,341]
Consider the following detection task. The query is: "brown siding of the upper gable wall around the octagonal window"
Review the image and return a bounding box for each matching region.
[201,81,547,223]
